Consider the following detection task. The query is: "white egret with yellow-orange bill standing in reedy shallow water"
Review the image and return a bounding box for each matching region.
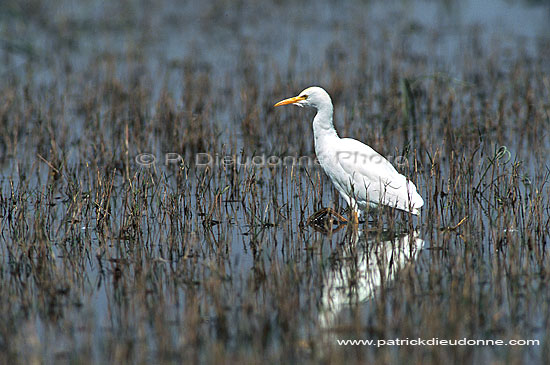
[275,86,424,222]
